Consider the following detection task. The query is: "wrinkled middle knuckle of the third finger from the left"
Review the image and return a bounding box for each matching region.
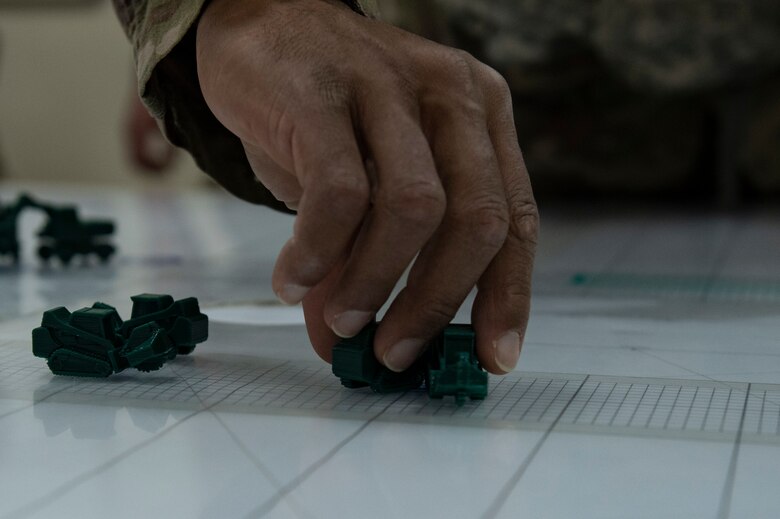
[455,193,510,250]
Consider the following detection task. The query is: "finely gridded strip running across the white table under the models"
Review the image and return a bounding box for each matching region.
[0,342,780,443]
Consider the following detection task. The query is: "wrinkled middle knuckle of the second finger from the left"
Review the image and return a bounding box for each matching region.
[378,180,447,224]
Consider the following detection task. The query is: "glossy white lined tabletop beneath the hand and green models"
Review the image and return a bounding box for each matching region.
[0,187,780,519]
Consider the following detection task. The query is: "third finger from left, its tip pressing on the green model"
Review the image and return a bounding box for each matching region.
[374,100,508,371]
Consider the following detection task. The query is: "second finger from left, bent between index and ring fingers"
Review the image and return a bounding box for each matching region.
[325,94,446,337]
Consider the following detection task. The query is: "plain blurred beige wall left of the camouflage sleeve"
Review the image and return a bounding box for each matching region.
[0,0,204,188]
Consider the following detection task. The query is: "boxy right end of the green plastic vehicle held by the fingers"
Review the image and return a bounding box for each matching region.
[426,324,488,406]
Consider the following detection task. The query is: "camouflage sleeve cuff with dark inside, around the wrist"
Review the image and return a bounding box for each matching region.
[113,0,373,207]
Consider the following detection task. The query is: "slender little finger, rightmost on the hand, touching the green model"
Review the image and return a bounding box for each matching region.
[471,68,539,374]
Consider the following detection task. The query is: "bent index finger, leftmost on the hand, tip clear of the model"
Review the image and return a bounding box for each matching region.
[272,113,369,304]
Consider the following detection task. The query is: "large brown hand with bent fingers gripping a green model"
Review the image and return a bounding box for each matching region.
[197,0,538,373]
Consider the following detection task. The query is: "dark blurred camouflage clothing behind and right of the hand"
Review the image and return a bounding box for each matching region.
[379,0,780,204]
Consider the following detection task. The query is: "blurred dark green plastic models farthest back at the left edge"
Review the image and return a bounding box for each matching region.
[0,195,116,265]
